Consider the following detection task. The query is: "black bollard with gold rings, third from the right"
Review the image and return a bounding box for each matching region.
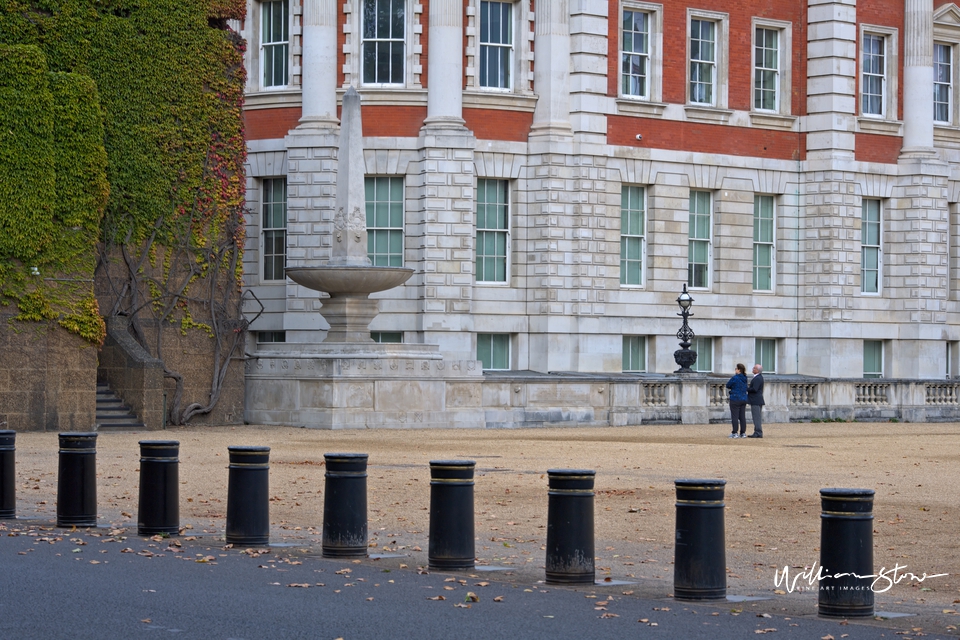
[546,469,596,584]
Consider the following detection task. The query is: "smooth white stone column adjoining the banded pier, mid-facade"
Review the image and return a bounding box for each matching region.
[530,0,573,137]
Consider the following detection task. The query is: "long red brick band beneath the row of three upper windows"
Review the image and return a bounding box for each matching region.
[607,116,807,160]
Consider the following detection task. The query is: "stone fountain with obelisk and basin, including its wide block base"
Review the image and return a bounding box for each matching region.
[245,87,486,429]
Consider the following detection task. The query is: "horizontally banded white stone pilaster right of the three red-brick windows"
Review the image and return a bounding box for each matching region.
[805,0,857,160]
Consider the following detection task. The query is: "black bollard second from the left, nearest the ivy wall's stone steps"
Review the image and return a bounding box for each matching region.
[57,433,97,527]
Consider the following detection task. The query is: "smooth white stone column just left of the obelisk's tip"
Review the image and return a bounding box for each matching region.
[300,0,339,128]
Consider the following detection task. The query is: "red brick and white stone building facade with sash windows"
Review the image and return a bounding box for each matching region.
[235,0,960,380]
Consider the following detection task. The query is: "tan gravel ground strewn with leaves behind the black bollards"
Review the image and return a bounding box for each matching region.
[7,423,960,634]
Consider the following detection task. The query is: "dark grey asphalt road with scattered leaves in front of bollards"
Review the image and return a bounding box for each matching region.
[0,521,947,640]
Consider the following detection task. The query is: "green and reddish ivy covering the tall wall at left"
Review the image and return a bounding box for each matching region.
[0,0,246,430]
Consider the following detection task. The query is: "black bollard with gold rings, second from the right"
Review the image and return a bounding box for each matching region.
[673,479,727,600]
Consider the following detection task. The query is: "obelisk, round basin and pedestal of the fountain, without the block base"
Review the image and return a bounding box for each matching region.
[286,87,413,344]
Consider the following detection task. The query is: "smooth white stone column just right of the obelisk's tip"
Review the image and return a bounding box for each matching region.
[424,0,464,129]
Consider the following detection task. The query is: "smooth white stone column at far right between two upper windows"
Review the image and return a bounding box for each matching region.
[901,0,935,157]
